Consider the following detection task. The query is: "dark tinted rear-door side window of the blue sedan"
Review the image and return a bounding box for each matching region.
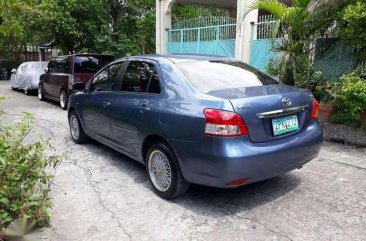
[121,61,160,93]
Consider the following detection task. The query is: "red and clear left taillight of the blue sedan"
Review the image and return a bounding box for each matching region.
[203,109,248,136]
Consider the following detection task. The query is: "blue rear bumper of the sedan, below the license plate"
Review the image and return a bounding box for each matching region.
[170,121,323,187]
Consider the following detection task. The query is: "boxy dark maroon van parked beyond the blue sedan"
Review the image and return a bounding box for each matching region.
[38,54,114,110]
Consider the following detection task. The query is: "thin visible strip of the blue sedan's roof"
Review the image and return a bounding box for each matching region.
[127,54,234,64]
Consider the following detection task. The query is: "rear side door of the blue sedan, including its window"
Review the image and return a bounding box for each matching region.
[110,60,161,155]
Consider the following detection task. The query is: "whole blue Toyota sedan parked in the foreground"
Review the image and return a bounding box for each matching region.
[68,55,323,198]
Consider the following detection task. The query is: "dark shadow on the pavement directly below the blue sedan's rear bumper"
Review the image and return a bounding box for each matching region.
[171,173,301,217]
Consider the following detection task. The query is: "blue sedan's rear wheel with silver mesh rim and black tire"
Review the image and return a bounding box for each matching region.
[146,142,189,199]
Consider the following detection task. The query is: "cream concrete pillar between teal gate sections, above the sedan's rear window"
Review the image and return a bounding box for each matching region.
[235,0,258,64]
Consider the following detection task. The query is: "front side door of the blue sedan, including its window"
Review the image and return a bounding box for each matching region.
[81,62,124,143]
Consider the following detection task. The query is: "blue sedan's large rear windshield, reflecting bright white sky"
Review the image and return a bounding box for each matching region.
[177,61,279,93]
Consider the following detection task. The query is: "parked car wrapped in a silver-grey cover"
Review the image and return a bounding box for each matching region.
[10,62,48,95]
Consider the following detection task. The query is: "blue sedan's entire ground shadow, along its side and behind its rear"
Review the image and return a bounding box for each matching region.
[79,137,301,218]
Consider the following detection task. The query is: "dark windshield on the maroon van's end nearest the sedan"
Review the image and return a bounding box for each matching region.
[74,55,114,73]
